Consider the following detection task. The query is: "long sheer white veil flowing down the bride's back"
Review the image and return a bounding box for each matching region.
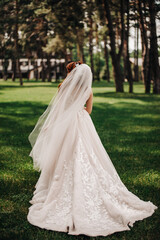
[28,64,92,170]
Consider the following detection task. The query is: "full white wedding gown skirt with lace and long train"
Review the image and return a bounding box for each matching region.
[27,63,157,236]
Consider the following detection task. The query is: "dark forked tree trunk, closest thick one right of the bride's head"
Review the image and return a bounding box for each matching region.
[103,0,124,92]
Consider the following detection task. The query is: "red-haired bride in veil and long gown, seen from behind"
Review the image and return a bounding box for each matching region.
[27,61,157,236]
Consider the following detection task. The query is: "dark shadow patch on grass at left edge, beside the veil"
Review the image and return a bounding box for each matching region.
[0,102,47,147]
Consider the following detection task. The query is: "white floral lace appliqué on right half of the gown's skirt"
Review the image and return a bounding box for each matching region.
[75,135,150,230]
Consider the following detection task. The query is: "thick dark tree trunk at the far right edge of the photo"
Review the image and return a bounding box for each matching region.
[149,0,160,94]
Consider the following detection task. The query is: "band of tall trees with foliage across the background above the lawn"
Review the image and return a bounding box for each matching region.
[0,0,160,93]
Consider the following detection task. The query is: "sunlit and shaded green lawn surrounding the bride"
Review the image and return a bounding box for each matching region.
[0,81,160,240]
